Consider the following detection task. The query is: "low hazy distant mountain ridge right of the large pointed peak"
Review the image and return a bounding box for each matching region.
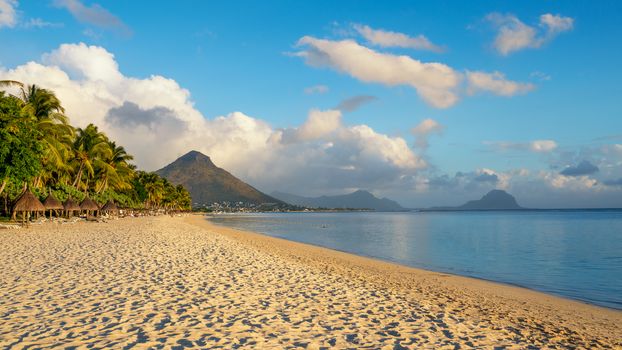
[272,190,405,211]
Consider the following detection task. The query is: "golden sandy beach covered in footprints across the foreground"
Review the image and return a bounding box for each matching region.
[0,215,622,349]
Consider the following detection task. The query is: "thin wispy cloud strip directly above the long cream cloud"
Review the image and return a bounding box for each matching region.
[353,24,443,52]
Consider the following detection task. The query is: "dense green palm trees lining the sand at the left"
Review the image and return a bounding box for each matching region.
[0,80,191,219]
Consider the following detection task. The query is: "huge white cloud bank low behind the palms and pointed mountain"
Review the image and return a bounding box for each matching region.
[0,44,426,194]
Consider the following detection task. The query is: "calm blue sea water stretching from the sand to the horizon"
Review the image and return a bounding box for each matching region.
[211,210,622,309]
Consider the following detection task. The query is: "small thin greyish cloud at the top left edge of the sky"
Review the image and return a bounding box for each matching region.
[54,0,130,33]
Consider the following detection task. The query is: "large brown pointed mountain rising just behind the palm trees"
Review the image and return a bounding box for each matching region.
[156,151,282,205]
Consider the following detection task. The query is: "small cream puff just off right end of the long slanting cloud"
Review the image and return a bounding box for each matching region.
[466,72,535,96]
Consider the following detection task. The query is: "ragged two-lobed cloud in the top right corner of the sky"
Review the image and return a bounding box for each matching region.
[486,13,574,55]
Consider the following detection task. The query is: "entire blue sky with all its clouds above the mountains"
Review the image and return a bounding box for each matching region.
[0,0,622,208]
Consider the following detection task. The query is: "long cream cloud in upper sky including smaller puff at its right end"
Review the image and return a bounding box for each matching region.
[294,36,533,108]
